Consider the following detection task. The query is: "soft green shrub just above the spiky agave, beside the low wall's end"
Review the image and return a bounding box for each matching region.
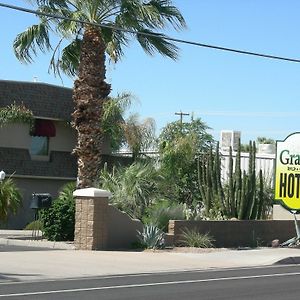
[143,200,187,232]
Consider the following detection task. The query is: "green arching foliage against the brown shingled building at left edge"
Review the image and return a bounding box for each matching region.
[0,103,34,128]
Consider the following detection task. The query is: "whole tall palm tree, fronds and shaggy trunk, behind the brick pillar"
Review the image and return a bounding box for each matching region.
[14,0,185,188]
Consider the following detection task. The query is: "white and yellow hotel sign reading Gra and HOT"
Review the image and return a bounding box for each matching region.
[275,132,300,213]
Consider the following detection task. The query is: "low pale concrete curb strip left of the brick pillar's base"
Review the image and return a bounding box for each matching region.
[0,238,75,250]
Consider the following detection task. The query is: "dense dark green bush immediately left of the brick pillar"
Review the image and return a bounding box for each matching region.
[41,182,76,241]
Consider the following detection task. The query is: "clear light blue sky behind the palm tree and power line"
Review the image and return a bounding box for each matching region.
[0,0,300,143]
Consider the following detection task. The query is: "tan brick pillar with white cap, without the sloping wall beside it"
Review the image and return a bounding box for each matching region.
[73,188,111,250]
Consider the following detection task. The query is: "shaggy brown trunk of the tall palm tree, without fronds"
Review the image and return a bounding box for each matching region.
[72,26,110,188]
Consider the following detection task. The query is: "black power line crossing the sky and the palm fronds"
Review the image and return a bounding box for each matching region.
[0,3,300,63]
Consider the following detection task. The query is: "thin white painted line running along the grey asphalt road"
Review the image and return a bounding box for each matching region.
[0,272,300,298]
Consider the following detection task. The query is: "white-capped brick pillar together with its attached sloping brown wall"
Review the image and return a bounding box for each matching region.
[74,188,143,250]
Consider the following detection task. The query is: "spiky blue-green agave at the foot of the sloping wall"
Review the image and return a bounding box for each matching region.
[137,225,164,249]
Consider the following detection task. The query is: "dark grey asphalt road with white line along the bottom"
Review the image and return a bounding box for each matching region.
[0,265,300,300]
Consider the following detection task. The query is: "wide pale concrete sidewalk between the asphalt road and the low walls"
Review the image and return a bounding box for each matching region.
[0,230,300,281]
